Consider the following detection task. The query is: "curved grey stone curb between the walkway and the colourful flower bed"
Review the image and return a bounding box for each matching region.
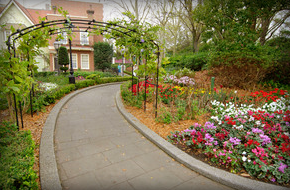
[116,91,289,190]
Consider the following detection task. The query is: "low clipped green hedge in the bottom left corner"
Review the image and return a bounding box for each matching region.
[0,122,38,190]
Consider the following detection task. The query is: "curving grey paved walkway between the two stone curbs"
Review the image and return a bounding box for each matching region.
[55,85,230,190]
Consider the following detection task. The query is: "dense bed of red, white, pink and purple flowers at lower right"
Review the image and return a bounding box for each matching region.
[168,90,290,184]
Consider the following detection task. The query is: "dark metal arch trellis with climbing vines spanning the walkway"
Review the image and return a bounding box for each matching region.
[6,17,160,127]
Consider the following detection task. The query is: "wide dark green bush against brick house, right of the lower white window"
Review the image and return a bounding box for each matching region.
[94,42,114,72]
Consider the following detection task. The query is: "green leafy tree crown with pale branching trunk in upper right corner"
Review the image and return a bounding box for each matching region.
[193,0,290,45]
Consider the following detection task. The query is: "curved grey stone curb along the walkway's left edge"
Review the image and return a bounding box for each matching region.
[39,82,123,190]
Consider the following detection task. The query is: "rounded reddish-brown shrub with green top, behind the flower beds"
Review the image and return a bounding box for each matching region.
[210,52,271,89]
